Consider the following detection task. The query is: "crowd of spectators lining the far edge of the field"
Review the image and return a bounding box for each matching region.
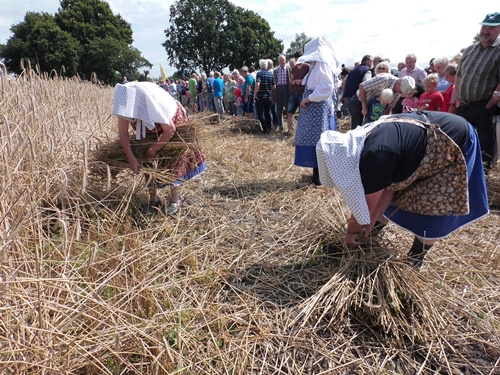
[148,9,500,173]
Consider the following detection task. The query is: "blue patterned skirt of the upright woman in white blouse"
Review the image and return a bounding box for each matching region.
[294,90,337,168]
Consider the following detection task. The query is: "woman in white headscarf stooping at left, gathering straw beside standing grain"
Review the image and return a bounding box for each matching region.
[113,82,206,216]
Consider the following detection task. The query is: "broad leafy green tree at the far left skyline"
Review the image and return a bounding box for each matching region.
[0,0,152,83]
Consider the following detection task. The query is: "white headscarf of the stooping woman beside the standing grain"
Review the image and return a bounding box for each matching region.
[113,82,177,139]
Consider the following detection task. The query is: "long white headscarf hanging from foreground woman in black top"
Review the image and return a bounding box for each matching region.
[316,120,381,225]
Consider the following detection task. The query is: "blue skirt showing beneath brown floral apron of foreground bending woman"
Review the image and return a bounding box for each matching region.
[384,124,489,239]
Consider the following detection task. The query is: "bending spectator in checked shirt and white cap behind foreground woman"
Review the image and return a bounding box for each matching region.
[350,73,415,129]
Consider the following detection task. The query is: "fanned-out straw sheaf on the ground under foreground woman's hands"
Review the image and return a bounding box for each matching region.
[292,206,446,342]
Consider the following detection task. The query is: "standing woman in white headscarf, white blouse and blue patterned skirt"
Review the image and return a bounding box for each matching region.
[294,36,342,187]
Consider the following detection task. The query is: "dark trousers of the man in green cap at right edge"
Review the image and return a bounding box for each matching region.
[457,105,497,169]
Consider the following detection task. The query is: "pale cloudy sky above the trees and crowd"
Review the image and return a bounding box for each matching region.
[0,0,492,77]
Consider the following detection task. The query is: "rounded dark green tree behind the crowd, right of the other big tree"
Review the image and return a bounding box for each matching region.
[162,0,283,72]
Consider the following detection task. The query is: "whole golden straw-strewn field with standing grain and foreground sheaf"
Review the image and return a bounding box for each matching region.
[0,68,500,375]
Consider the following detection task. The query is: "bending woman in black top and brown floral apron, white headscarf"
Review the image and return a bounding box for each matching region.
[316,111,489,269]
